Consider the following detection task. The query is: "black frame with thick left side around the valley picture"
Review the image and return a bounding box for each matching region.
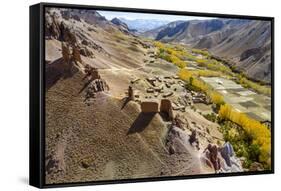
[29,3,275,188]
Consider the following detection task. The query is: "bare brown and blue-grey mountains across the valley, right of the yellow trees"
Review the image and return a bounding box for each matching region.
[141,19,271,83]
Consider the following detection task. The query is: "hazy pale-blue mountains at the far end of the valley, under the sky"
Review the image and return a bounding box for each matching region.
[118,18,169,32]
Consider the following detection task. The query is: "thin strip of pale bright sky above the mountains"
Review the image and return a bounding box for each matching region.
[98,11,213,22]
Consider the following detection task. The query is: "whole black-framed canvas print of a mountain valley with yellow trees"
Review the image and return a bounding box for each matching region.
[30,3,274,188]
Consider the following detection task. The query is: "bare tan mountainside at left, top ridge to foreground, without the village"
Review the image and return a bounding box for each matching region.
[45,9,228,184]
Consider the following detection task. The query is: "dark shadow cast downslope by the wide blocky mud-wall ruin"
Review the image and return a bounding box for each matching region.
[127,112,156,135]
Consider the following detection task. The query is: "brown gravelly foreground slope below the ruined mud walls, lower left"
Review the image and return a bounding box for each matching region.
[46,70,203,183]
